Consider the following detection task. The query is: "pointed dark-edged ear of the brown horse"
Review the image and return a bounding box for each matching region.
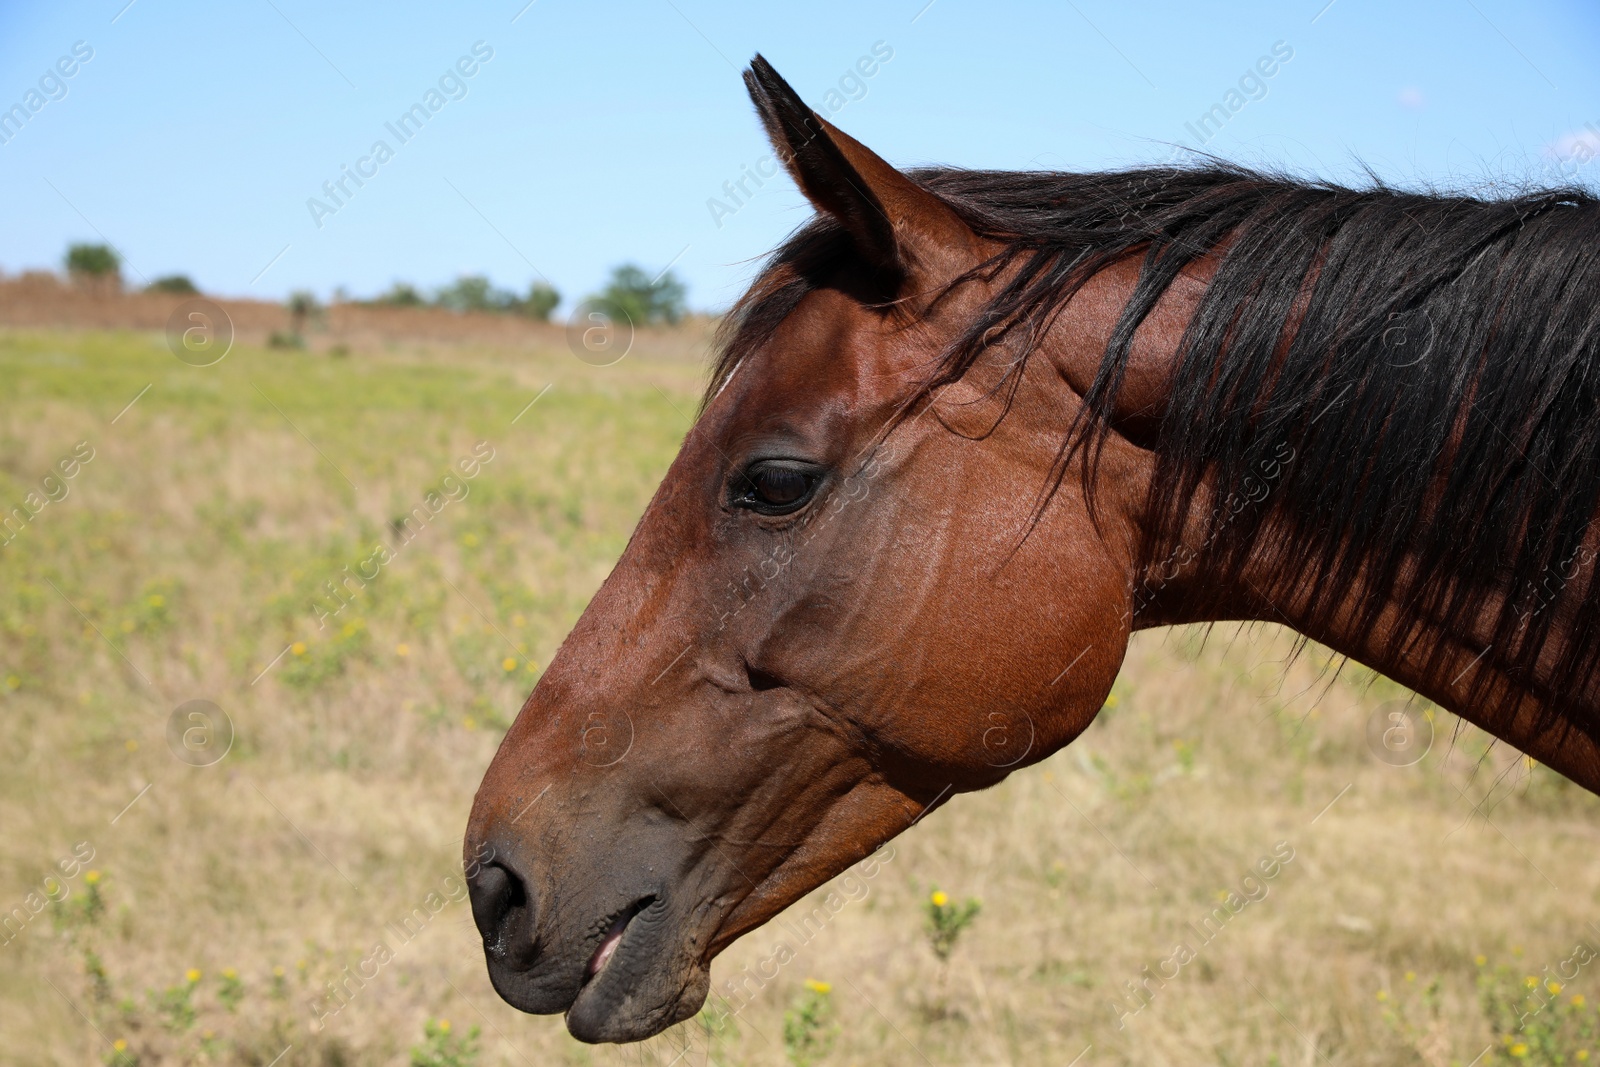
[744,54,978,288]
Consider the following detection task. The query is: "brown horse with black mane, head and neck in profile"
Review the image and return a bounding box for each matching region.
[464,56,1600,1041]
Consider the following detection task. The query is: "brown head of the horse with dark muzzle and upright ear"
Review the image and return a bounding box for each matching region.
[467,58,1141,1041]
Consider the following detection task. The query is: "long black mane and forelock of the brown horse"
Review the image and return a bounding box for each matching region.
[710,165,1600,739]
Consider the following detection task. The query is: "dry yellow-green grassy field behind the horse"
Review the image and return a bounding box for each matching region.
[0,330,1600,1067]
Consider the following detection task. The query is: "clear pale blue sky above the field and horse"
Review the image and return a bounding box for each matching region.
[0,0,1600,310]
